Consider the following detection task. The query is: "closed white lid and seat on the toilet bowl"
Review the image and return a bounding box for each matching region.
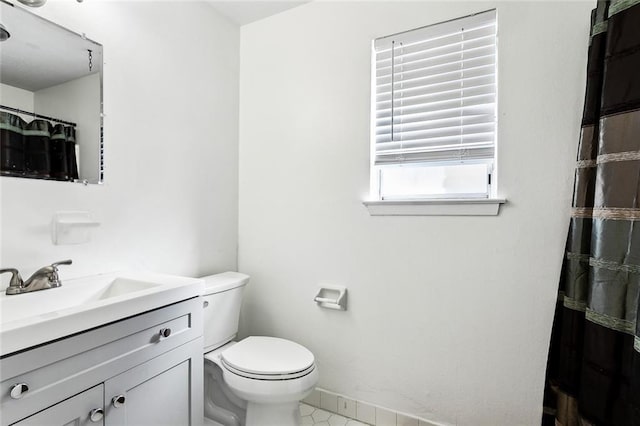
[220,336,315,380]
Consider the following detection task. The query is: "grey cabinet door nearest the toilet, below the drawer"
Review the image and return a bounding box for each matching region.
[104,339,203,426]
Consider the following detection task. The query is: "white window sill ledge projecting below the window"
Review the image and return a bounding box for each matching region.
[363,198,507,216]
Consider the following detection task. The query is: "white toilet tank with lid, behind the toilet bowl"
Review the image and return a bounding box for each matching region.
[202,272,249,352]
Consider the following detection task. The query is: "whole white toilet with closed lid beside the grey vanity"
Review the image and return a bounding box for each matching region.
[203,272,318,426]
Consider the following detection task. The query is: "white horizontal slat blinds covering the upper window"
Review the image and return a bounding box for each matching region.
[374,10,496,166]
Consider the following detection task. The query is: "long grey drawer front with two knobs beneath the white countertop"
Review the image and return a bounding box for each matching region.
[0,298,202,425]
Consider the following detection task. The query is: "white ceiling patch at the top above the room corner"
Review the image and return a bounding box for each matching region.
[208,0,311,25]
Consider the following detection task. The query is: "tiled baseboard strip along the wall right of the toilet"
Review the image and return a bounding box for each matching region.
[302,388,443,426]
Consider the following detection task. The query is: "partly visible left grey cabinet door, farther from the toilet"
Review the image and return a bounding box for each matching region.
[13,384,104,426]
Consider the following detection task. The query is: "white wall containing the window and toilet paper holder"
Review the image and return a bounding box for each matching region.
[239,1,595,426]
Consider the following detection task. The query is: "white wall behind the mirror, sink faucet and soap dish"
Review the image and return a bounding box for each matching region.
[0,0,239,285]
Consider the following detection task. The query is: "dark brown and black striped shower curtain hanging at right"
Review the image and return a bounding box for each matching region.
[542,0,640,426]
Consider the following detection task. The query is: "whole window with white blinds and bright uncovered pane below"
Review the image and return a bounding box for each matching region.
[371,10,497,201]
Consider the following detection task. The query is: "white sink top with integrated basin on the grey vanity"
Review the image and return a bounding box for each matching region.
[0,273,204,356]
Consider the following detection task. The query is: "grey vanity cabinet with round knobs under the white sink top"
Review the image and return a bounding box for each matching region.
[0,296,203,426]
